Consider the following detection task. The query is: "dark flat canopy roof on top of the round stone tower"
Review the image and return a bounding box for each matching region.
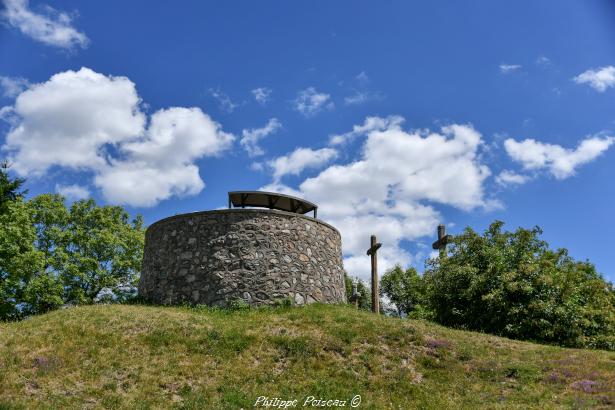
[228,191,318,218]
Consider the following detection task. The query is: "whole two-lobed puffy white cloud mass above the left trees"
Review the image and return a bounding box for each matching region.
[3,68,234,206]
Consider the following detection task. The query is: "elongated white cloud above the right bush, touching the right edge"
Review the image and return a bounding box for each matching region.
[504,136,615,179]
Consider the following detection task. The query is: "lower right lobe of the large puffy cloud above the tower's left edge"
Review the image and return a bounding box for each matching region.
[94,107,234,207]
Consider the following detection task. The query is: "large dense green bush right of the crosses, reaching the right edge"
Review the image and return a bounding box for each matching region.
[423,221,615,349]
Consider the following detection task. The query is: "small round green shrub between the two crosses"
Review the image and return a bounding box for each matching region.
[380,265,425,316]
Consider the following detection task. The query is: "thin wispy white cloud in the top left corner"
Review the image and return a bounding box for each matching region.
[1,0,89,49]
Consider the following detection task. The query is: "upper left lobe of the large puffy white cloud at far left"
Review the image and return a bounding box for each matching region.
[4,68,146,175]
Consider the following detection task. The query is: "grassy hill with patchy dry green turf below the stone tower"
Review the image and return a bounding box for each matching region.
[0,305,615,409]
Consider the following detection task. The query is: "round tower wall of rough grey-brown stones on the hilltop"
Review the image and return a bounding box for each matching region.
[139,209,346,306]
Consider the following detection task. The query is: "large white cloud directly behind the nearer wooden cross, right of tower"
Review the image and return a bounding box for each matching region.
[263,116,490,279]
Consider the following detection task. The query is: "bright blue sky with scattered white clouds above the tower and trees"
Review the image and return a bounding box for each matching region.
[0,0,615,280]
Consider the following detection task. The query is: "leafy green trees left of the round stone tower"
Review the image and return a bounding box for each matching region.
[0,194,144,320]
